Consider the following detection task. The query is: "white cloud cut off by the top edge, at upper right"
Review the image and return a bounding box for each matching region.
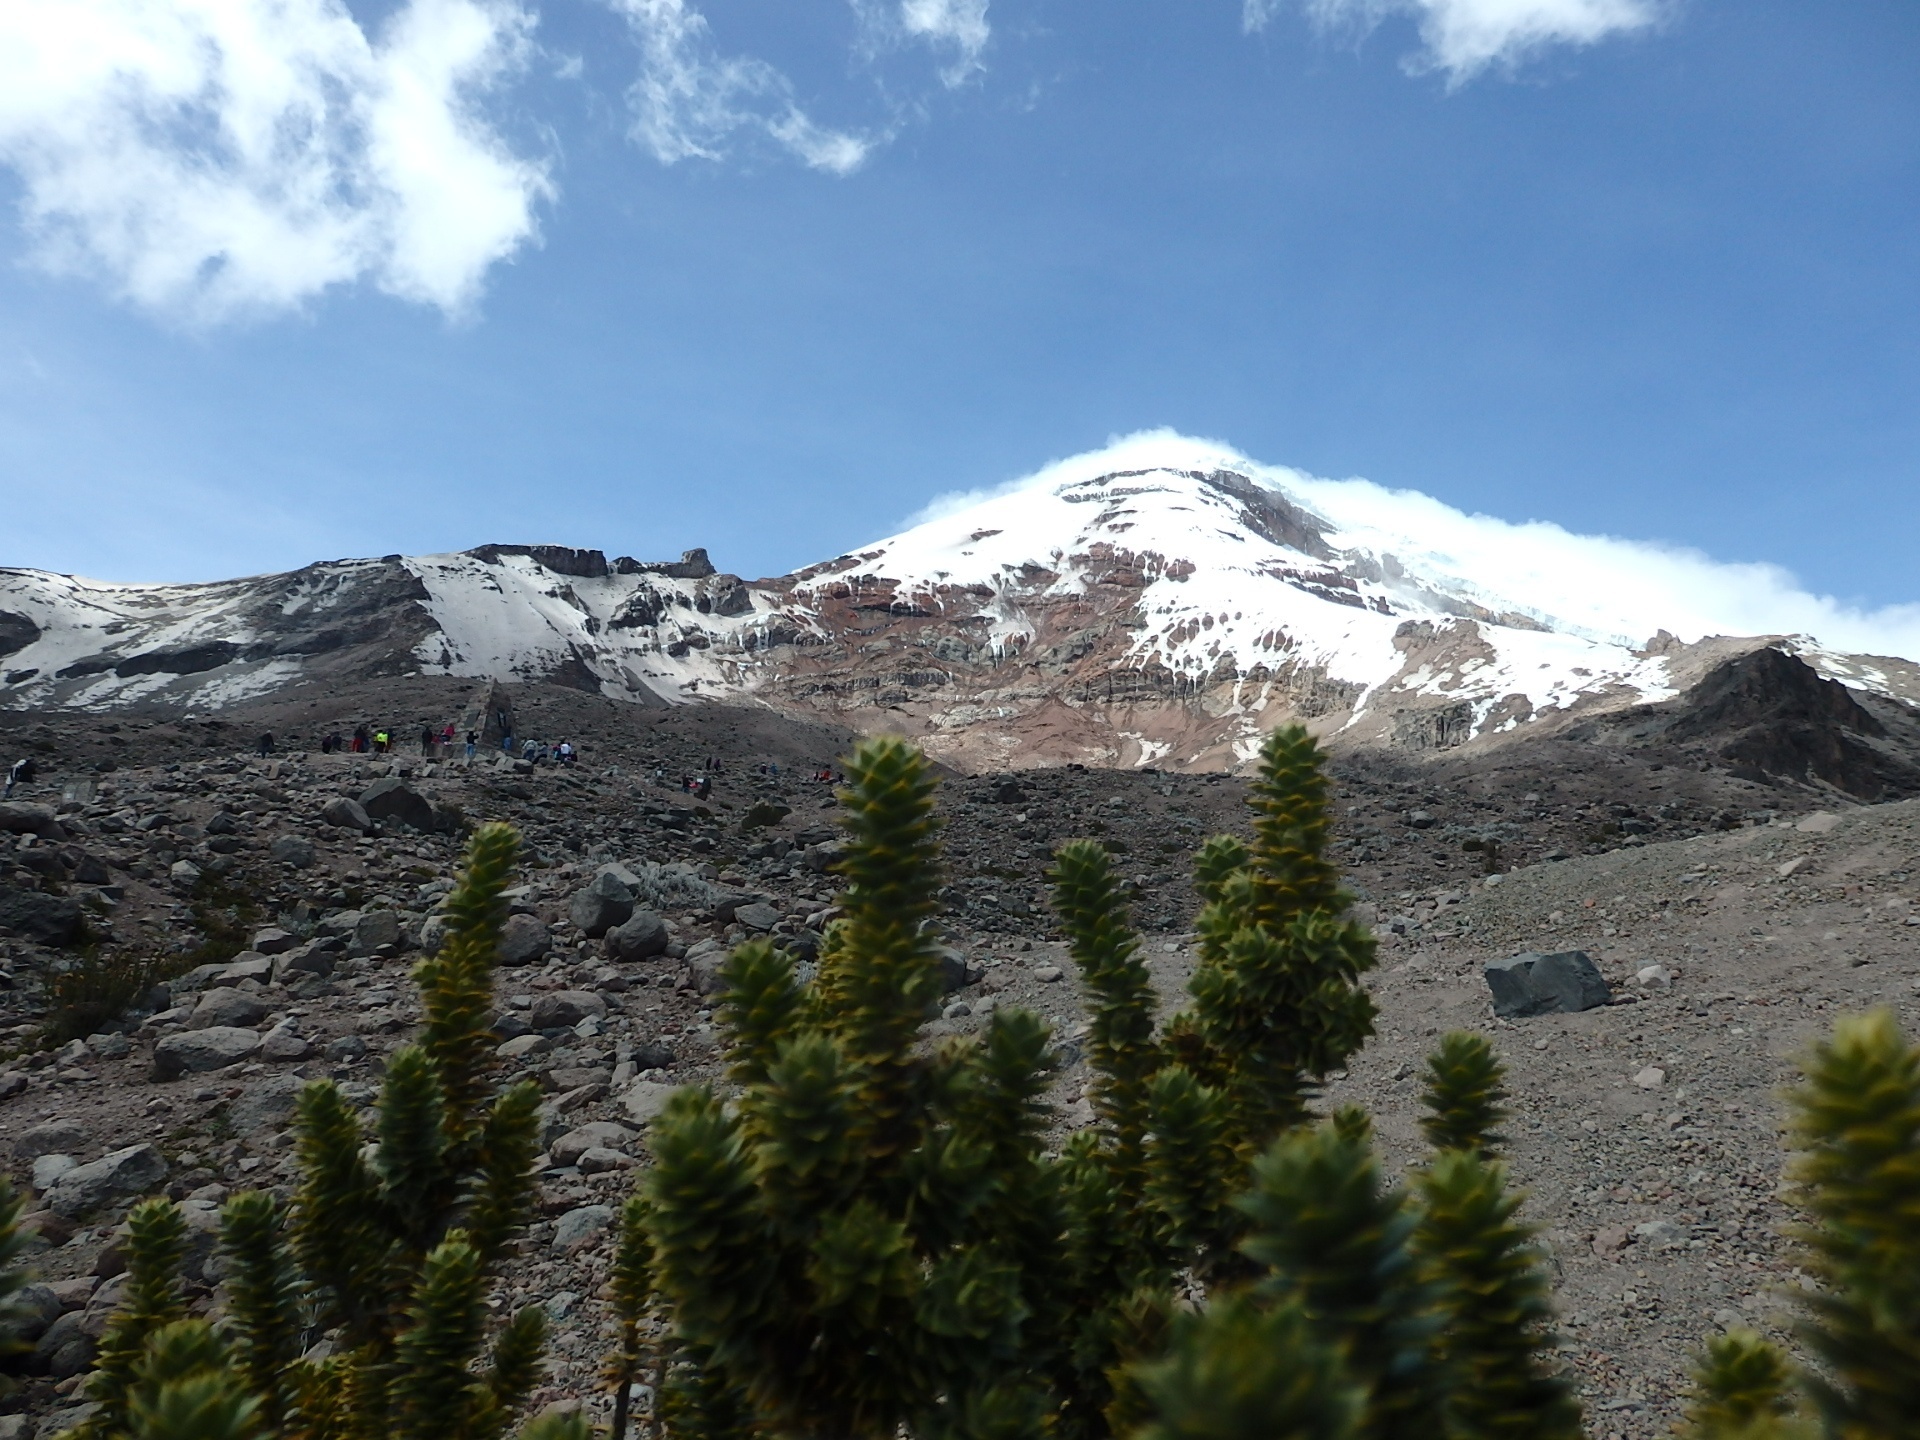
[1242,0,1667,84]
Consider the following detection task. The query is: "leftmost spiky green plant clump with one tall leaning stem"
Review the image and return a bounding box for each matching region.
[90,826,553,1440]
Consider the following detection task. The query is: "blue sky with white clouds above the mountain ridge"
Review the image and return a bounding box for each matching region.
[0,0,1920,607]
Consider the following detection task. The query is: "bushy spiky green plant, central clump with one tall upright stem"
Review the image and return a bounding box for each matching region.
[643,739,1062,1440]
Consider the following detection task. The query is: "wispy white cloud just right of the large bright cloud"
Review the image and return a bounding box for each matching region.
[612,0,874,175]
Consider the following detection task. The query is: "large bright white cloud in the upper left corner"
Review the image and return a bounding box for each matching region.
[0,0,549,321]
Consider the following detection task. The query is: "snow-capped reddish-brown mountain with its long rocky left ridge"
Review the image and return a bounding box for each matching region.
[0,436,1920,768]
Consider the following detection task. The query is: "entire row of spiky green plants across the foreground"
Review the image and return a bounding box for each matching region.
[0,728,1920,1440]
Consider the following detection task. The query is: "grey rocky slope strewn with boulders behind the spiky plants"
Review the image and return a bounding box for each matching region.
[0,695,1920,1438]
